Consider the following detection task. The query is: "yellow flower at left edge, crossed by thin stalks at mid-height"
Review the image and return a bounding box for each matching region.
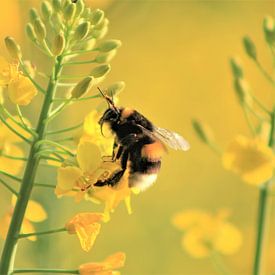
[0,116,30,174]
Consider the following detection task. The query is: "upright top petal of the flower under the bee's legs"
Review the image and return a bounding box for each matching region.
[77,140,100,173]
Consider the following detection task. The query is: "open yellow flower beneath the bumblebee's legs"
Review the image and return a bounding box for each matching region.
[55,140,134,219]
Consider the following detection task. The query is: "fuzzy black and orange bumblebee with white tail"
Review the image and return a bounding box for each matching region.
[94,89,190,190]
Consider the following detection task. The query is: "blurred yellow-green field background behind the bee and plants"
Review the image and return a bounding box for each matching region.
[0,0,275,275]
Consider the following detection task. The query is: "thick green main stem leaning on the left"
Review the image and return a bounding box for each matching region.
[0,57,62,275]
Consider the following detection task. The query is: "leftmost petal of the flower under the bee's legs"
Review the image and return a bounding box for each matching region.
[56,166,83,192]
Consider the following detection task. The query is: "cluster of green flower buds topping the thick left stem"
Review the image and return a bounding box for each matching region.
[26,0,121,64]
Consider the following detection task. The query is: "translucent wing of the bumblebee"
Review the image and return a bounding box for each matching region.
[153,126,190,151]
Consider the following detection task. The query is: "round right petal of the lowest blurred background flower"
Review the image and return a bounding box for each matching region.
[214,222,242,255]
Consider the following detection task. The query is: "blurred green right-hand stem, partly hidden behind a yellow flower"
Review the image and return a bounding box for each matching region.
[253,109,275,275]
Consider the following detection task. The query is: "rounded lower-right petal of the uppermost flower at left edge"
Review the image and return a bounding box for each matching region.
[8,75,37,105]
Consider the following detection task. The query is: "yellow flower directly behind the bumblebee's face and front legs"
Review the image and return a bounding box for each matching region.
[81,110,114,156]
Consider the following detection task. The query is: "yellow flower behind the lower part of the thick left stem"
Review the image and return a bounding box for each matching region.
[0,196,47,241]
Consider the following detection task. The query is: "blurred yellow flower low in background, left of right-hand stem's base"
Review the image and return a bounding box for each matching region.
[172,210,242,258]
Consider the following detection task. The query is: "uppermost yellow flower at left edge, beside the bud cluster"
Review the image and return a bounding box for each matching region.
[0,56,37,105]
